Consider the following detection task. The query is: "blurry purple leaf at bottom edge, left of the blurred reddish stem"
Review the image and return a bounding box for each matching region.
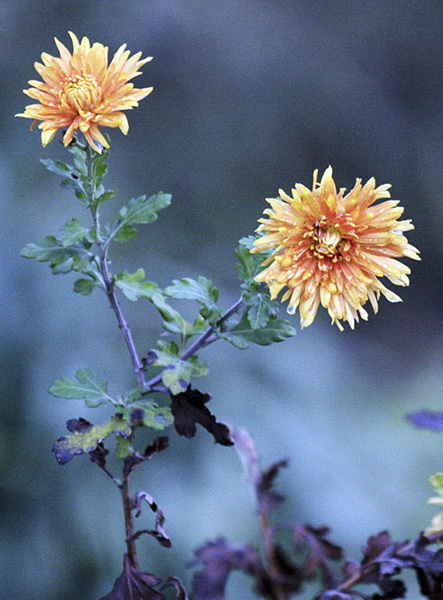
[192,538,264,600]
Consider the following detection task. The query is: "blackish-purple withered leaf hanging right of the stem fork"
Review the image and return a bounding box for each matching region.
[171,387,234,446]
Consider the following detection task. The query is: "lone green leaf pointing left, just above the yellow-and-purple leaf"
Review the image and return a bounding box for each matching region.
[49,369,116,408]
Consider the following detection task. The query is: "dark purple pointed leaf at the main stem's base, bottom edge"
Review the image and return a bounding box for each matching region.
[100,554,165,600]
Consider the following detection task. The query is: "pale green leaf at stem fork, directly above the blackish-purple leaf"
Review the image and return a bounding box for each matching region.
[152,341,208,394]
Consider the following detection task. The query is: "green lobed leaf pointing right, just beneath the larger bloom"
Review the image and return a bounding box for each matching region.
[221,315,295,349]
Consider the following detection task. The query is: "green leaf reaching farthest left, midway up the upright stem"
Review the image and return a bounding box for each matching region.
[20,235,94,274]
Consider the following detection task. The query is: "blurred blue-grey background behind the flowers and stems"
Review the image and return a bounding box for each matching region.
[0,0,443,600]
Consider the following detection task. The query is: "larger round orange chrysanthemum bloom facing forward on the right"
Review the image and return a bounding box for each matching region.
[252,167,420,331]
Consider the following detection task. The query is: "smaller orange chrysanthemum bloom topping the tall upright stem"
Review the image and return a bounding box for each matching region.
[16,32,153,153]
